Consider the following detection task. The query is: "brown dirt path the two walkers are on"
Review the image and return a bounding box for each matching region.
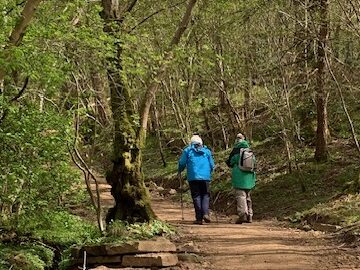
[90,179,360,270]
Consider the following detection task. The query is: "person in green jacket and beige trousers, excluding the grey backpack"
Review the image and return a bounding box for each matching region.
[226,133,256,224]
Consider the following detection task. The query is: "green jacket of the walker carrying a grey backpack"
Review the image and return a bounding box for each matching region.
[226,140,256,189]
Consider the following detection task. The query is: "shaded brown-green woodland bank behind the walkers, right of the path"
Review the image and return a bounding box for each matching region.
[144,136,360,235]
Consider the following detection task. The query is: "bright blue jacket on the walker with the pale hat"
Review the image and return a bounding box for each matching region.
[178,144,215,181]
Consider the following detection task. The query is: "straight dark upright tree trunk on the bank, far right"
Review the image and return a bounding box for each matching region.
[315,0,329,161]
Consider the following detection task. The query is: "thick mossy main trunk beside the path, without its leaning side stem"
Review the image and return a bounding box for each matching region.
[102,0,155,223]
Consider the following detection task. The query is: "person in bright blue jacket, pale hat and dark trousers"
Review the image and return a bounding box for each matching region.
[178,135,215,225]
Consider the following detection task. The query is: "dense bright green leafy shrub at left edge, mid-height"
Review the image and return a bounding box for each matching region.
[0,106,79,218]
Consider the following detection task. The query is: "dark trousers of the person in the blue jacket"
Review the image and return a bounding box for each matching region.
[189,180,210,221]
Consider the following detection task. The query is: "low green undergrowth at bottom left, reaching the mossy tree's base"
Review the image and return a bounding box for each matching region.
[0,210,175,270]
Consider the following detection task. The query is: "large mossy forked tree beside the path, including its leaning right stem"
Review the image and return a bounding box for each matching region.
[102,0,196,222]
